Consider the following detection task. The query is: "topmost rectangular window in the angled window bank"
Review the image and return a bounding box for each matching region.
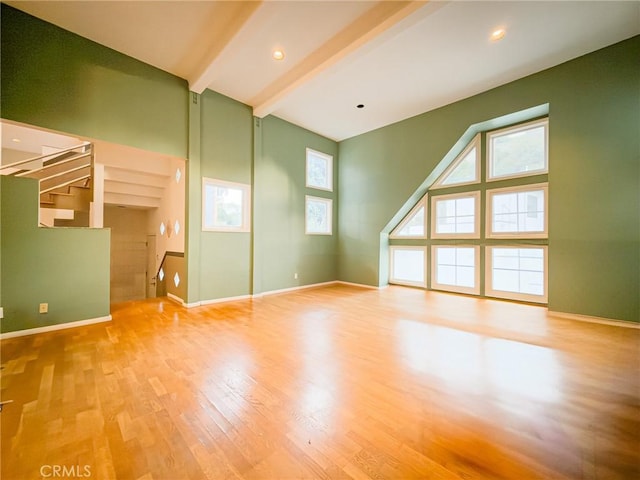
[487,119,549,180]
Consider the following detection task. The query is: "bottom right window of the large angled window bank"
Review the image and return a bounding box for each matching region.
[486,246,547,303]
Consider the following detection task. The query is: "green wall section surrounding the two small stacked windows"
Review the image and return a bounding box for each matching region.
[254,116,338,293]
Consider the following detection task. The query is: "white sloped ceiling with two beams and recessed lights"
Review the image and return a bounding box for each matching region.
[5,0,640,140]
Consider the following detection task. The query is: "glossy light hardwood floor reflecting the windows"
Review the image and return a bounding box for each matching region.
[0,285,640,480]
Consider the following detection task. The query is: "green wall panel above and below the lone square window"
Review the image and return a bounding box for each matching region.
[199,90,253,300]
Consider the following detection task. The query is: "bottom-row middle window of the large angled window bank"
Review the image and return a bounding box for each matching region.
[431,245,480,295]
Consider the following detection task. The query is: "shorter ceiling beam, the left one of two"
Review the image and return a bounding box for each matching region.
[187,1,263,94]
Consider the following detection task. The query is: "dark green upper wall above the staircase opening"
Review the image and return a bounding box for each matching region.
[1,4,188,158]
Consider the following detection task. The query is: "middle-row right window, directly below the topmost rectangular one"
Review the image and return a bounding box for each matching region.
[487,183,548,238]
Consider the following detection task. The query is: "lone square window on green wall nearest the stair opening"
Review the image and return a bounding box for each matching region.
[202,178,251,232]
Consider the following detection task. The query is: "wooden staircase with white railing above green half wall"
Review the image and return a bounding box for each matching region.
[0,142,94,227]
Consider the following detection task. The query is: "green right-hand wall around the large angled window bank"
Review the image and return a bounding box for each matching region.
[339,37,640,321]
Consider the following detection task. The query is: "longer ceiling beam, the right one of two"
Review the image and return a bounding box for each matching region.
[249,0,427,118]
